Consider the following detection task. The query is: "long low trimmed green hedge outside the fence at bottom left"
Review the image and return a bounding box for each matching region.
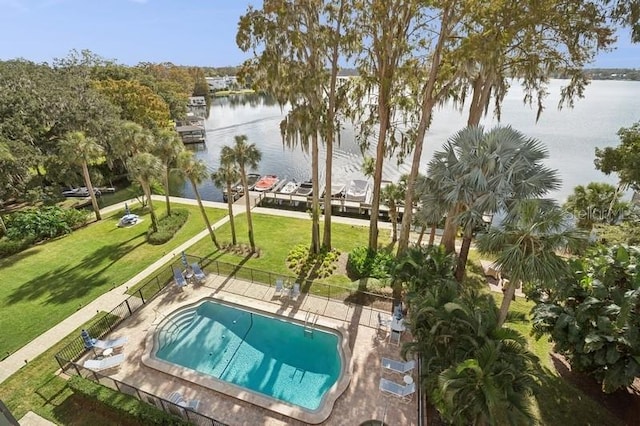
[67,376,190,425]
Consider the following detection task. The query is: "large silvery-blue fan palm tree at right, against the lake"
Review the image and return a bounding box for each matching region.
[427,126,560,281]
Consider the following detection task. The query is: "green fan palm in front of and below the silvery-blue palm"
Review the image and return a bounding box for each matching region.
[476,199,587,325]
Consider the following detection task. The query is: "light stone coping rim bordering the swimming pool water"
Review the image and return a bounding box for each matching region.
[142,296,352,424]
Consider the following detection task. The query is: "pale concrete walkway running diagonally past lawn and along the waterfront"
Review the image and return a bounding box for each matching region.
[0,195,402,383]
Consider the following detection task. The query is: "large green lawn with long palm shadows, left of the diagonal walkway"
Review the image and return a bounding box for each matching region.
[0,202,226,358]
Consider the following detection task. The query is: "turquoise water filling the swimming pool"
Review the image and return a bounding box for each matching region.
[156,301,341,410]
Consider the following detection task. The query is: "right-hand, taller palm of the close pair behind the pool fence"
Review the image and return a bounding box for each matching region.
[220,135,260,252]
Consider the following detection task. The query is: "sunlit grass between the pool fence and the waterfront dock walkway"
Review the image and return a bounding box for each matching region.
[188,214,390,286]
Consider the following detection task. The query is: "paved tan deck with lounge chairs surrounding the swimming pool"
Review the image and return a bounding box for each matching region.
[92,274,417,425]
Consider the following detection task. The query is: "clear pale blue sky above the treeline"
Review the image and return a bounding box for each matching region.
[0,0,640,68]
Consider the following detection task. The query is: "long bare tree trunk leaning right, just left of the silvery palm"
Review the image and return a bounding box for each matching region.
[394,6,453,256]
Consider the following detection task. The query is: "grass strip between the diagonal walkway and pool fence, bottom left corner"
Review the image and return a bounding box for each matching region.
[0,313,138,426]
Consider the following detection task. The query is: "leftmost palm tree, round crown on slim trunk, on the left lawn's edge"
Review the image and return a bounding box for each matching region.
[59,131,104,220]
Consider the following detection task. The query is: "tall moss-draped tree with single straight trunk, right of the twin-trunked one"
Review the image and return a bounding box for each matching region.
[352,0,425,250]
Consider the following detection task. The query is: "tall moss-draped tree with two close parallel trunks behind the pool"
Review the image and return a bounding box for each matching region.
[236,0,357,253]
